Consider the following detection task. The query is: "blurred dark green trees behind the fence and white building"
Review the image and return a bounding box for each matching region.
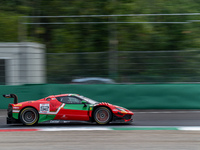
[0,0,200,83]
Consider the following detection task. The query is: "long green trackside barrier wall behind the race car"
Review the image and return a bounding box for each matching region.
[0,84,200,109]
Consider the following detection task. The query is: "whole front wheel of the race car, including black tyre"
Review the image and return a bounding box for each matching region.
[94,107,112,125]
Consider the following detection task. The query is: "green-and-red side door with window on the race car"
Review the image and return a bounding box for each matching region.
[56,96,89,121]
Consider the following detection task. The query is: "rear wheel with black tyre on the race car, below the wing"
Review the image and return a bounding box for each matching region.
[20,107,39,126]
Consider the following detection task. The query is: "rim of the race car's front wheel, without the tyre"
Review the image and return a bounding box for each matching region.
[96,109,110,123]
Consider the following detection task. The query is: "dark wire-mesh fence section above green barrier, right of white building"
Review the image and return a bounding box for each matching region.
[46,50,200,84]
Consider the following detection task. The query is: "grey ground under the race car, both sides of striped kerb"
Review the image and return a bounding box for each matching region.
[0,110,200,150]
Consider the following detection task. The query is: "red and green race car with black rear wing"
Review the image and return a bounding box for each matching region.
[3,94,134,126]
